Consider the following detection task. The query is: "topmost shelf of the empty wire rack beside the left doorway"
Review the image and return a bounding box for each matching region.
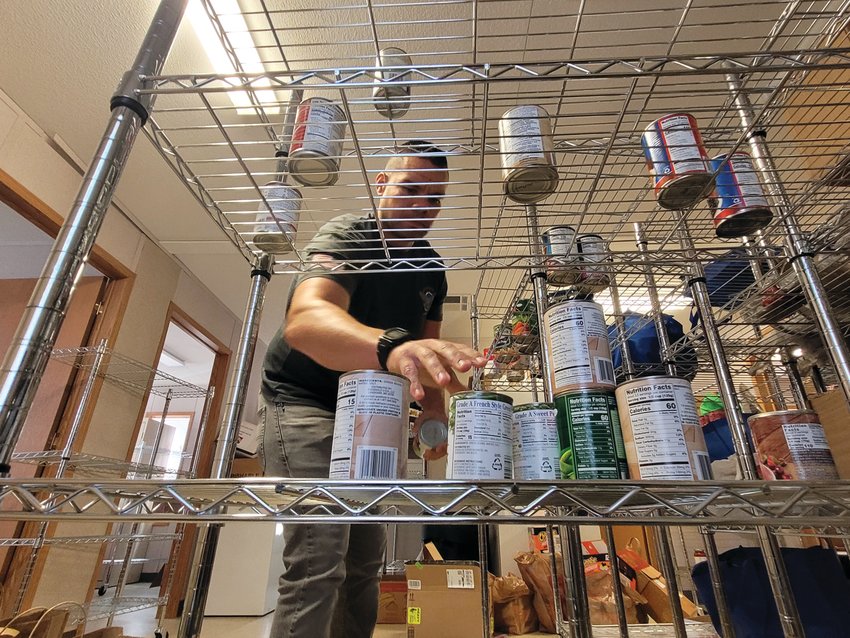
[50,347,207,399]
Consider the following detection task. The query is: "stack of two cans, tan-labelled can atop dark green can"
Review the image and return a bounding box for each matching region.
[543,300,629,479]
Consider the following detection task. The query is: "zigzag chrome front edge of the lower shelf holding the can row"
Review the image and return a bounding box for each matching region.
[0,479,850,527]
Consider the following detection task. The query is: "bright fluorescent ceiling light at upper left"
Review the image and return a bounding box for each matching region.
[186,0,280,115]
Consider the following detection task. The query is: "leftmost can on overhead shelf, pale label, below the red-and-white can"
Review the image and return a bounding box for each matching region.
[251,182,301,255]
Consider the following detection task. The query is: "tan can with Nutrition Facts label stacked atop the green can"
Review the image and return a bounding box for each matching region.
[543,300,617,396]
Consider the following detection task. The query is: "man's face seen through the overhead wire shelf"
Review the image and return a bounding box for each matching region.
[375,155,449,247]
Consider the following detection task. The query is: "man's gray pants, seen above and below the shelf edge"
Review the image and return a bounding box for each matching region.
[259,396,386,638]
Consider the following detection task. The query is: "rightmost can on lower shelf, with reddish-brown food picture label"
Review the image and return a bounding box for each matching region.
[747,410,838,481]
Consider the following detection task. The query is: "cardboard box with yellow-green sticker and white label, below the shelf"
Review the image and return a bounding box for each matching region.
[405,561,484,638]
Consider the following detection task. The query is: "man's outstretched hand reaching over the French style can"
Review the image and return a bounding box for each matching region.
[387,339,487,401]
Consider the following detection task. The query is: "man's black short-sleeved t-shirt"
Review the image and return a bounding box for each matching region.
[262,215,447,411]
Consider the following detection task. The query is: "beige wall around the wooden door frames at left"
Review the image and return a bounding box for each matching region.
[0,92,264,606]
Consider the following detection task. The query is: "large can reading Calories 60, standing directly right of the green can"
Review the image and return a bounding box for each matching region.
[617,375,711,480]
